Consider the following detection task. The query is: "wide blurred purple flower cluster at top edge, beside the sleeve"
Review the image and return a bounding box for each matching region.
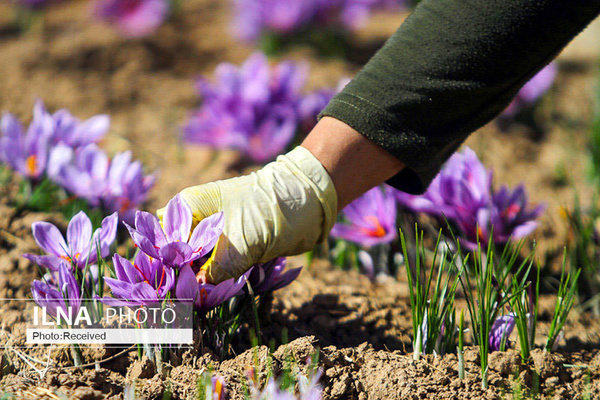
[233,0,402,42]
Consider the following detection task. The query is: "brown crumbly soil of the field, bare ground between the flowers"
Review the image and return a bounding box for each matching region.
[0,0,600,399]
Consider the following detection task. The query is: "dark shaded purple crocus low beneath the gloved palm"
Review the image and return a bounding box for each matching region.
[248,257,302,294]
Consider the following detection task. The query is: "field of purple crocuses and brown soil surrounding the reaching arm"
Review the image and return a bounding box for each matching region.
[0,0,600,400]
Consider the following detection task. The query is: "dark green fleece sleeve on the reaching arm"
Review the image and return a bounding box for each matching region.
[321,0,600,193]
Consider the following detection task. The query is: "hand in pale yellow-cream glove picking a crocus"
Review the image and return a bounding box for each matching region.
[157,147,337,283]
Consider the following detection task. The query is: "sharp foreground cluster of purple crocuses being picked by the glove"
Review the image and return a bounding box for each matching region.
[24,195,301,315]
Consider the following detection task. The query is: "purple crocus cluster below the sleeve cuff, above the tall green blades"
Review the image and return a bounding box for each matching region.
[396,147,545,249]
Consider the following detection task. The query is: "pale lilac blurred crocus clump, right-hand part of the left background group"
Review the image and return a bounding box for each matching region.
[55,144,155,221]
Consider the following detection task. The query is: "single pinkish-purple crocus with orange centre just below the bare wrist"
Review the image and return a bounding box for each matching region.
[331,186,397,247]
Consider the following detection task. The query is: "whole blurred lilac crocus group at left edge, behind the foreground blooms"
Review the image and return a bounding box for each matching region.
[0,101,154,220]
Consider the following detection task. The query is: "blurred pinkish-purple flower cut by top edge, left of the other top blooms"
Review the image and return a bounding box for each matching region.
[94,0,169,37]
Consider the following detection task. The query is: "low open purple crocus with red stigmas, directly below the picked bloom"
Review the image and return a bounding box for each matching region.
[104,251,175,305]
